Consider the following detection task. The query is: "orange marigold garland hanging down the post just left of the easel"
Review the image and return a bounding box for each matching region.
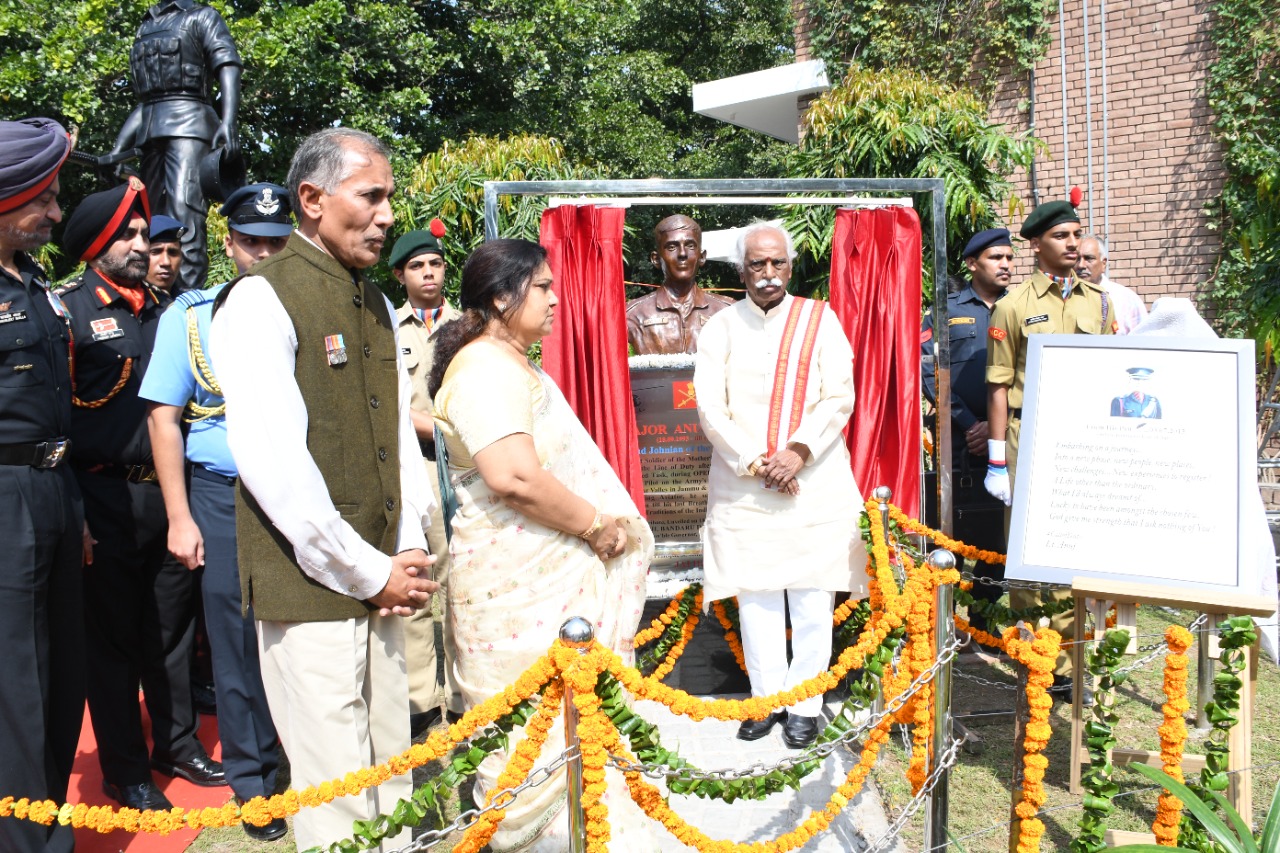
[1005,626,1062,853]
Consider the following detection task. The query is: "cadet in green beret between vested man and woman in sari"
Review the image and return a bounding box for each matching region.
[388,219,465,736]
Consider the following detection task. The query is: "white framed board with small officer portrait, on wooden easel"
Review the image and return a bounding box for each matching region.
[1006,334,1257,594]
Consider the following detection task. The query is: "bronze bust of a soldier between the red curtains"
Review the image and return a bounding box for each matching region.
[627,214,733,355]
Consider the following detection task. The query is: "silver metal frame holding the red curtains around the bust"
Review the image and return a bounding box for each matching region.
[484,178,952,849]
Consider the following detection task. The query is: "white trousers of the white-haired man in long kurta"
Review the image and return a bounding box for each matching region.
[737,589,836,717]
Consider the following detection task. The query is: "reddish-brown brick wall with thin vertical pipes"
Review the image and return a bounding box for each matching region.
[983,0,1222,300]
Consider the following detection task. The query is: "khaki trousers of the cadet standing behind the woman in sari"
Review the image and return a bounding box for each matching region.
[404,460,466,713]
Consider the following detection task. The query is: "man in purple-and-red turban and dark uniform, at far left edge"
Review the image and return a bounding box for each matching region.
[0,118,83,853]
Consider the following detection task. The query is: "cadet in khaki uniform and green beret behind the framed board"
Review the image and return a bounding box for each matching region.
[986,201,1116,693]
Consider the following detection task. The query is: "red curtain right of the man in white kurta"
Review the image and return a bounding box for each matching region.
[831,207,920,517]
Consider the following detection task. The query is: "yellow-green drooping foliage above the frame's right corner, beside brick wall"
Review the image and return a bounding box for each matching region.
[787,67,1037,295]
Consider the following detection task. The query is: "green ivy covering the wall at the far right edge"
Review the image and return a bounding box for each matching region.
[1208,0,1280,348]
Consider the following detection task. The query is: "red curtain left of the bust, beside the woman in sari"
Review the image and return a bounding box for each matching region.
[539,205,644,514]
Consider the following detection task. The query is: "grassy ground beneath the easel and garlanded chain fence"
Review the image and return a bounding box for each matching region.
[189,607,1280,853]
